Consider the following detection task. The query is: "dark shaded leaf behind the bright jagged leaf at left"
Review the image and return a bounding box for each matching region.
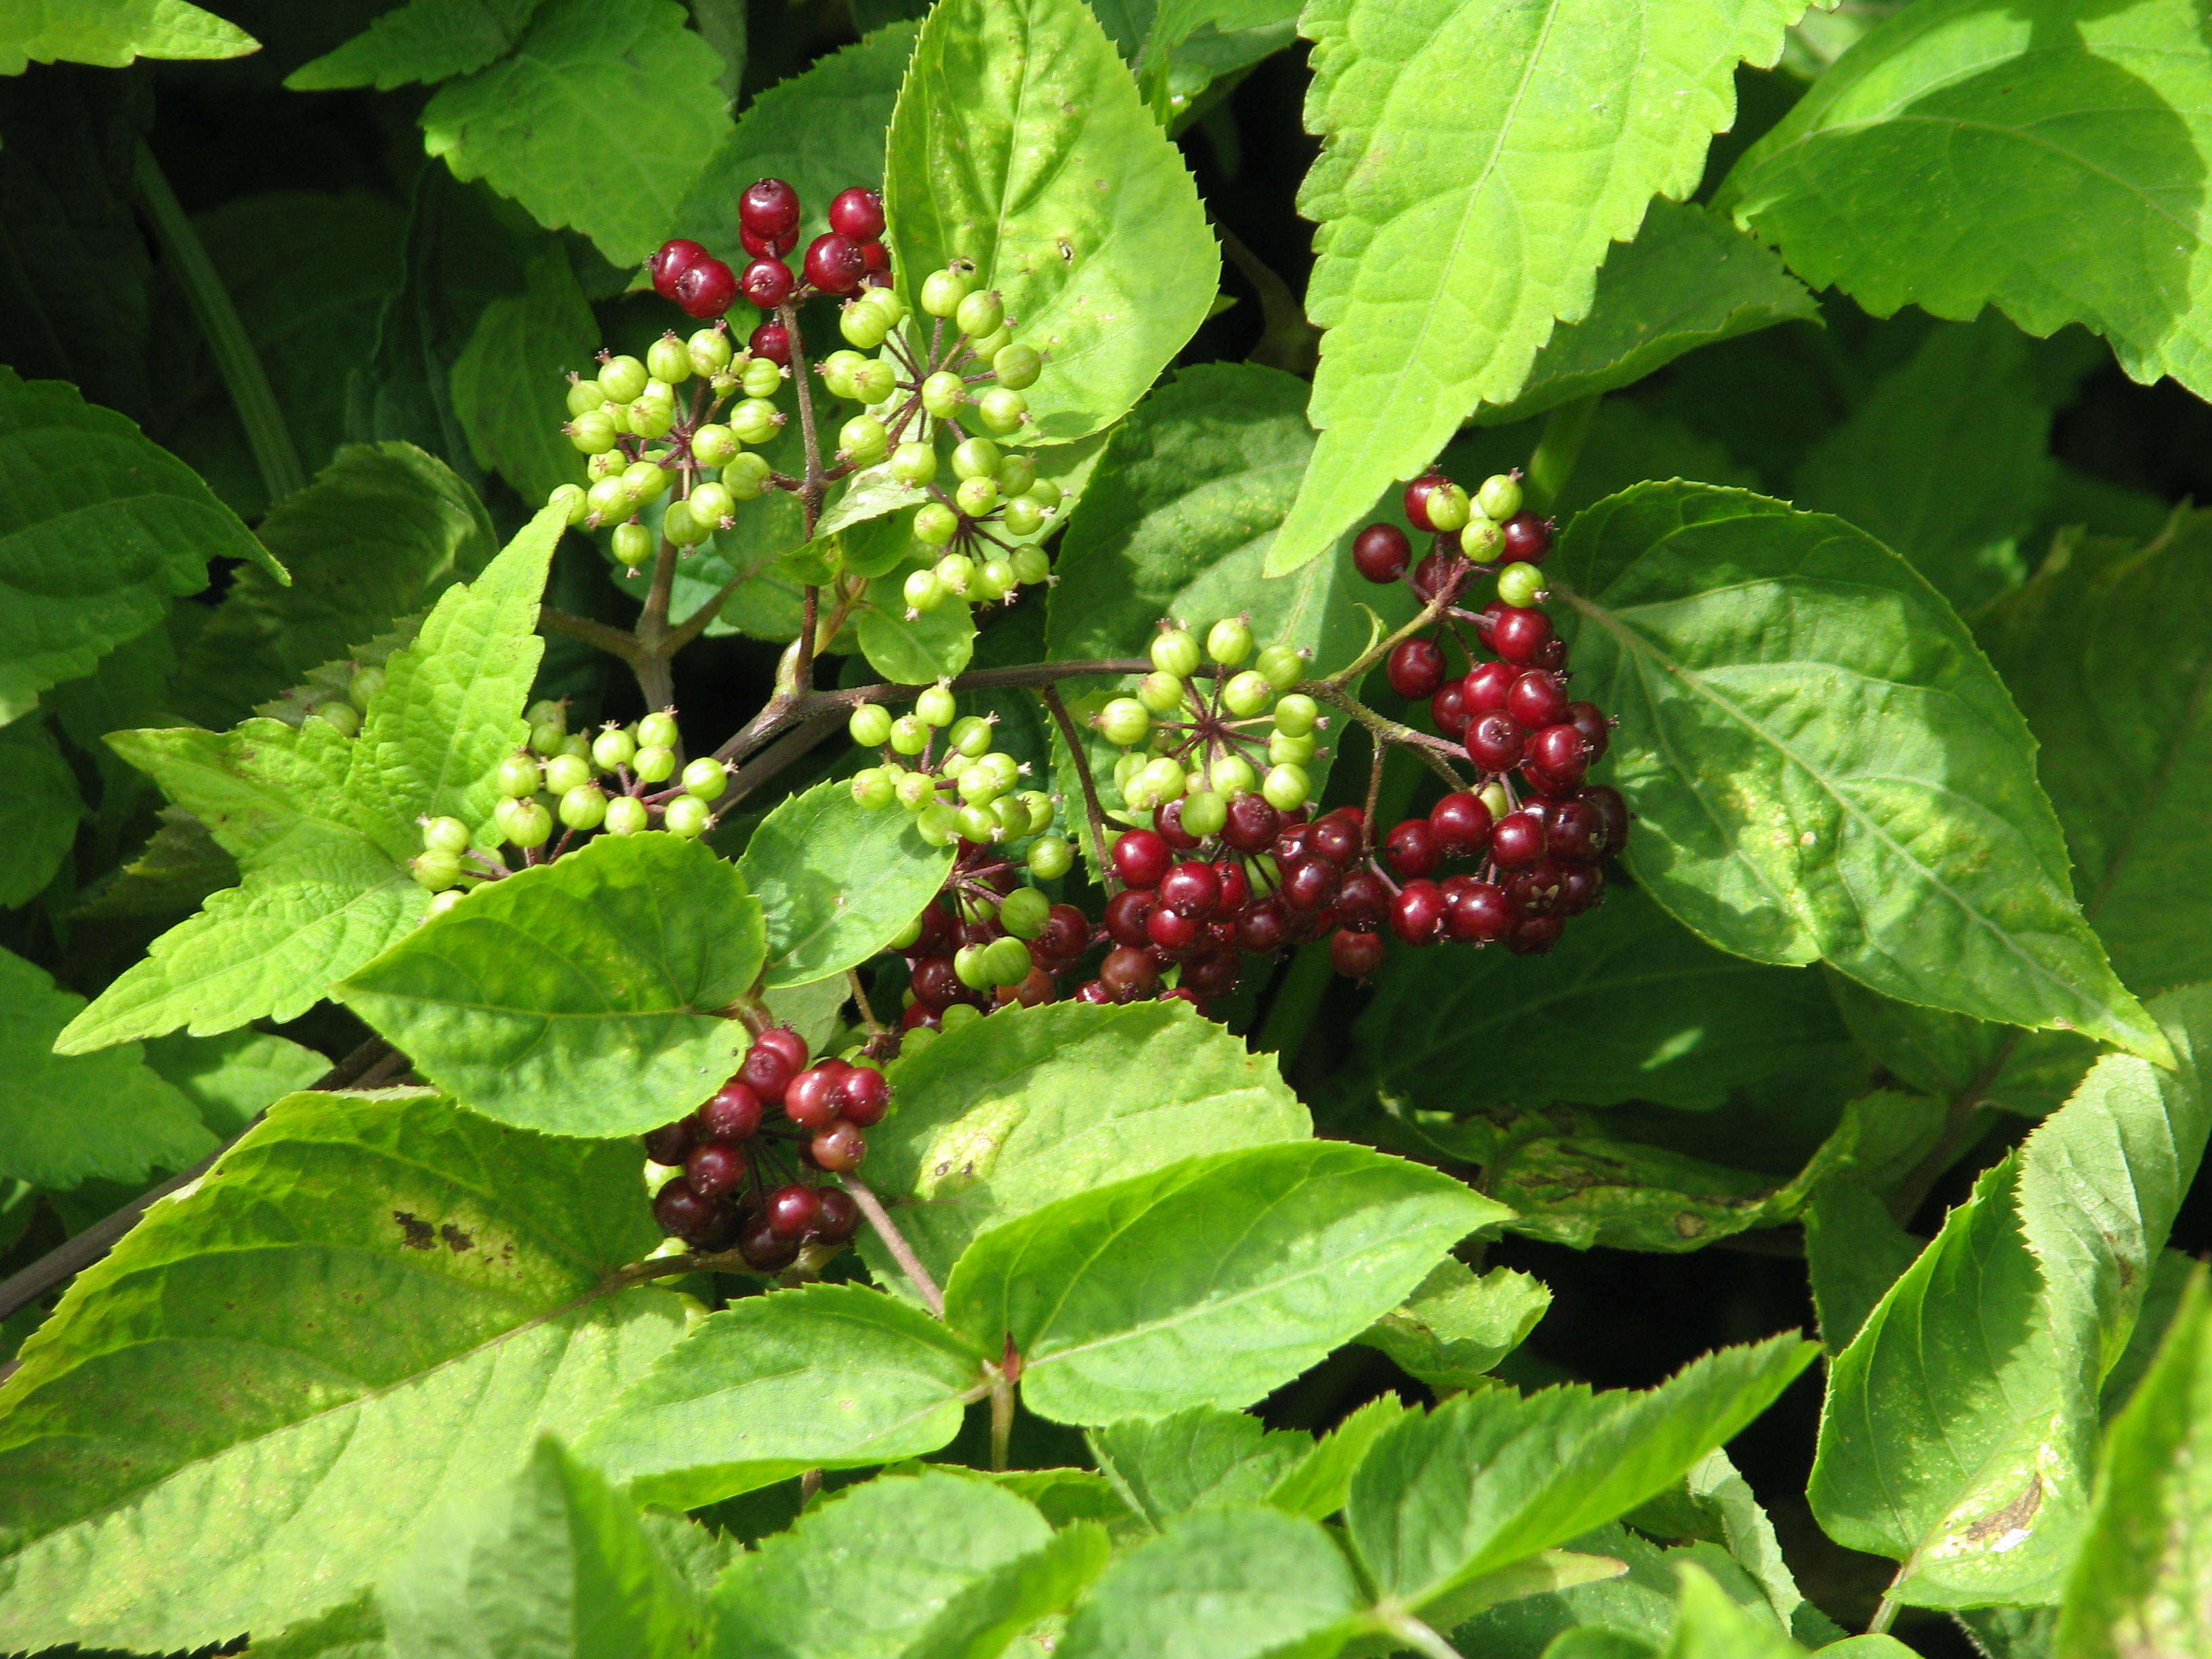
[177,443,497,726]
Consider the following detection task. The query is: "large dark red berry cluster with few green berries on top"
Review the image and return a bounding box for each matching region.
[1336,473,1628,973]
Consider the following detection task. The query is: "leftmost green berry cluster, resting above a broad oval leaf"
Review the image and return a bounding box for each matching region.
[411,701,730,914]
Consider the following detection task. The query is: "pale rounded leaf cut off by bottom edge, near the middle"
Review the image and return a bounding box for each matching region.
[1055,1509,1367,1659]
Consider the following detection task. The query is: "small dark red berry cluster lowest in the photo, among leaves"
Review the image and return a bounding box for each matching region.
[646,1026,891,1272]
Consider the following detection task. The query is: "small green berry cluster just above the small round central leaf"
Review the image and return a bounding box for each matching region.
[849,681,1075,880]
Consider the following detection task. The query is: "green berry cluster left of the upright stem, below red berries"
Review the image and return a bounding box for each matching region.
[551,323,787,571]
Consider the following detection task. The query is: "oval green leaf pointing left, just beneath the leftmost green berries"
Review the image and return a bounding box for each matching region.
[336,832,765,1134]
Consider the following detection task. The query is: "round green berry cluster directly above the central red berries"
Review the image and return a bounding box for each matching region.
[1090,617,1323,838]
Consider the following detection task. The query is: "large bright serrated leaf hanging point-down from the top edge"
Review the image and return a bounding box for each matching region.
[1267,0,1805,575]
